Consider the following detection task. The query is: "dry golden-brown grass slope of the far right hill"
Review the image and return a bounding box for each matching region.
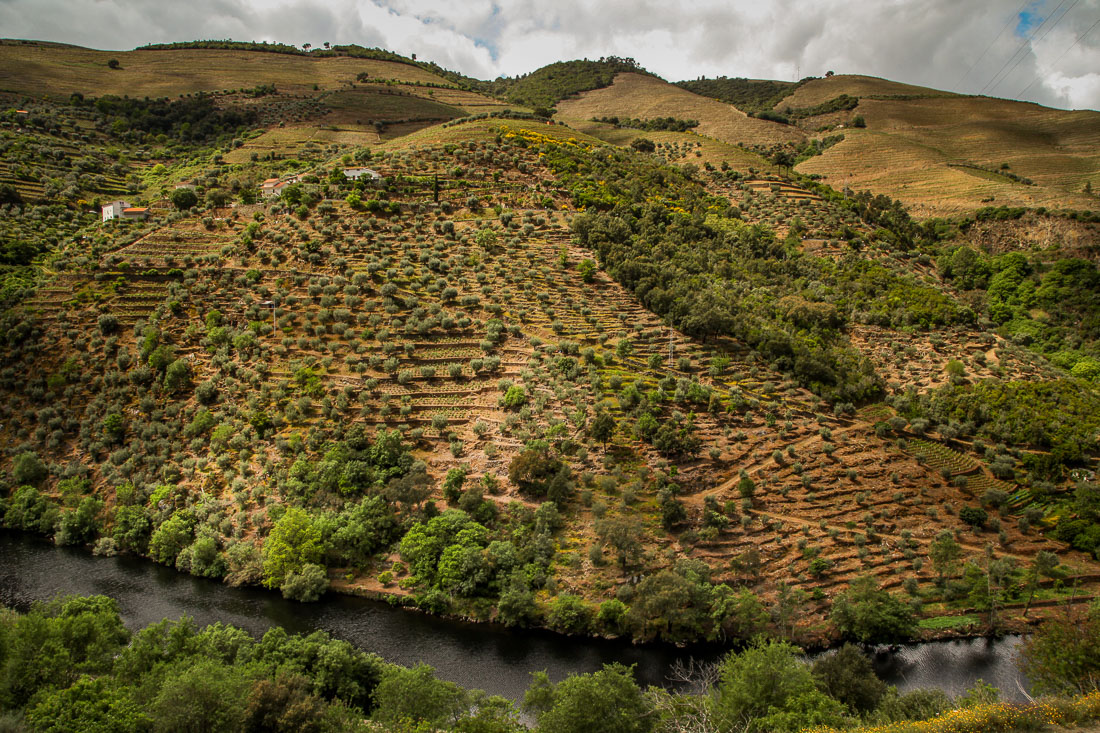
[799,97,1100,217]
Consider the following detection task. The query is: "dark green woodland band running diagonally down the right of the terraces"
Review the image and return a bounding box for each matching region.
[546,135,974,402]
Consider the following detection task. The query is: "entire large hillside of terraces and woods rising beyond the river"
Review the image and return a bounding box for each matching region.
[0,38,1100,643]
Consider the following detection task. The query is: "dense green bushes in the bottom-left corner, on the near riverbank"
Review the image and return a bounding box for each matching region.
[0,595,387,733]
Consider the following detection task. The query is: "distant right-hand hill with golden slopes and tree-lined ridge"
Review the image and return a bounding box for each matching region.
[646,75,1100,218]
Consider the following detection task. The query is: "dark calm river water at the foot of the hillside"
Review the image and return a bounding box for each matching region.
[0,530,1026,700]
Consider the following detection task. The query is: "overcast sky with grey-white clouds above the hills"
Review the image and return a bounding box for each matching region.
[0,0,1100,109]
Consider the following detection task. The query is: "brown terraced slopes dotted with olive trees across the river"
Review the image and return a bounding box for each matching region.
[4,112,1095,634]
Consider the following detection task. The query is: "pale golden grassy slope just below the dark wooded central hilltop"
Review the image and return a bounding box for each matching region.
[558,74,805,145]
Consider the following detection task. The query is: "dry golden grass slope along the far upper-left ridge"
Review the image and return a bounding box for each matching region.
[0,41,448,97]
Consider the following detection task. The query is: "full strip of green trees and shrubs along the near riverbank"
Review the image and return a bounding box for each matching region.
[0,595,1100,733]
